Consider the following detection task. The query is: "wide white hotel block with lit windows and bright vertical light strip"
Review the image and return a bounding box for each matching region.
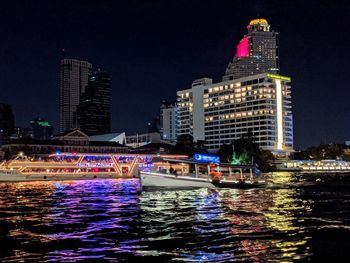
[177,73,293,154]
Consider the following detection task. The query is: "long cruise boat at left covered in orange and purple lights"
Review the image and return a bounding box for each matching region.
[0,153,187,182]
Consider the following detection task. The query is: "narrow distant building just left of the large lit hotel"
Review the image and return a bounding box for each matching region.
[159,101,178,141]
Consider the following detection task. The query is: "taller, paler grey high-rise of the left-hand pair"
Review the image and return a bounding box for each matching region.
[60,59,92,132]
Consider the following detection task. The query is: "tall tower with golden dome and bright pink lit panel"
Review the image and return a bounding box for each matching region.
[222,18,279,81]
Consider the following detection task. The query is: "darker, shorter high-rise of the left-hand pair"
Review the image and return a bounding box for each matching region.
[77,71,111,136]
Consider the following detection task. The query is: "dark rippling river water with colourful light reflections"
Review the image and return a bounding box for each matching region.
[0,173,350,262]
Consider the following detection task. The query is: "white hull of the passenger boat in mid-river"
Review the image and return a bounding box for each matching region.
[140,172,215,189]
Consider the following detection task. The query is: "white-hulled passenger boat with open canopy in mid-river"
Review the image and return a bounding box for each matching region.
[140,158,266,191]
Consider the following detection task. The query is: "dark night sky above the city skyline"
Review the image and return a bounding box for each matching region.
[0,0,350,148]
